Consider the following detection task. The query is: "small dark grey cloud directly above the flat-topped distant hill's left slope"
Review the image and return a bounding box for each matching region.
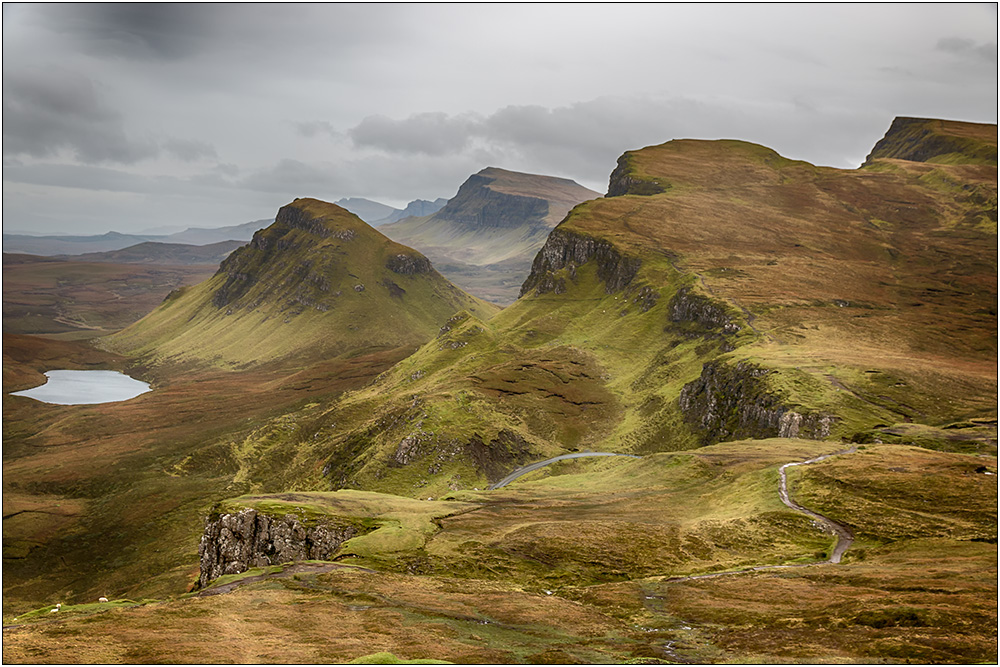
[347,112,479,155]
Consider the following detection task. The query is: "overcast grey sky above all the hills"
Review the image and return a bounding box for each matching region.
[3,3,997,234]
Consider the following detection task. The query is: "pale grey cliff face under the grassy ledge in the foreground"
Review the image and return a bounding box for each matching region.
[198,508,362,588]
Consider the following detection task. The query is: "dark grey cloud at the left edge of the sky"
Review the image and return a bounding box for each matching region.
[3,67,159,163]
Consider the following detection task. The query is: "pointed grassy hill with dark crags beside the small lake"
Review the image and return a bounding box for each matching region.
[105,199,496,367]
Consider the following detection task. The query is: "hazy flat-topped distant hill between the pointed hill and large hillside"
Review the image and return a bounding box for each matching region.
[380,167,600,304]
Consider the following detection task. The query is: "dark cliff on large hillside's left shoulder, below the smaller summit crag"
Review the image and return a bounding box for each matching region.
[520,229,642,296]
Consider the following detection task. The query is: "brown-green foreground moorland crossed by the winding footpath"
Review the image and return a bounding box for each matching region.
[4,440,997,664]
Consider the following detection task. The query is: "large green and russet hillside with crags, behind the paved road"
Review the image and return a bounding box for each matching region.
[217,117,997,495]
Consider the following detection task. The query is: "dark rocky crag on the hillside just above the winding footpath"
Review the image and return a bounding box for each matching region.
[678,362,835,445]
